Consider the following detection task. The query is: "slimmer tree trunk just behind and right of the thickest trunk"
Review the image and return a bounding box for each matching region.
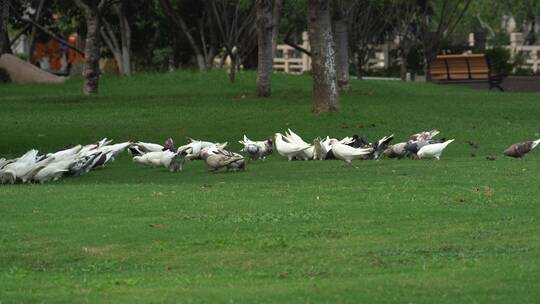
[334,18,351,91]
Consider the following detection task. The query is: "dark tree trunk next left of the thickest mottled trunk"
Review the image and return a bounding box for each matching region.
[256,0,274,97]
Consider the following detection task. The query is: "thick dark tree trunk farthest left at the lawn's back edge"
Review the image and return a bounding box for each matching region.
[79,1,101,95]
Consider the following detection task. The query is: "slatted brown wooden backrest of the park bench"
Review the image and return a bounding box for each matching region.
[430,54,489,81]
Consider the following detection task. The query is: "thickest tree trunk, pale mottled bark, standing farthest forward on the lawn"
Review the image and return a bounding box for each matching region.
[307,0,340,113]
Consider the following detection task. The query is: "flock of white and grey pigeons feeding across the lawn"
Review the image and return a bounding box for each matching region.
[0,129,540,184]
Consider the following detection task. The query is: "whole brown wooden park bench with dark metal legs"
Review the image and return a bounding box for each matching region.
[430,54,504,91]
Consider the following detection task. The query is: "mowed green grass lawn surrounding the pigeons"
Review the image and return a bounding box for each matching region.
[0,72,540,303]
